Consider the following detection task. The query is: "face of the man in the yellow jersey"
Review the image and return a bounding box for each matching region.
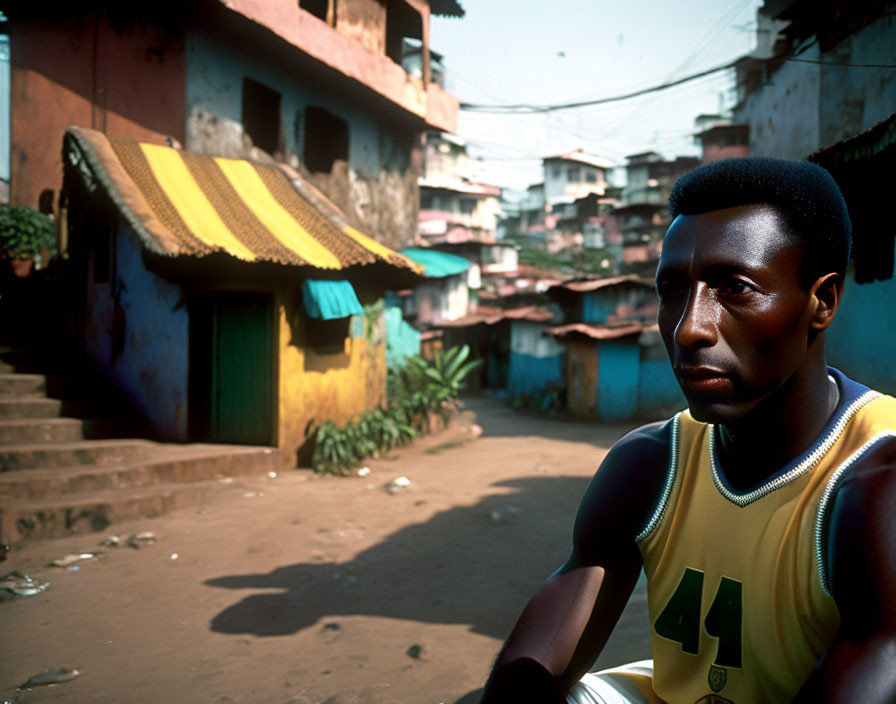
[657,205,810,424]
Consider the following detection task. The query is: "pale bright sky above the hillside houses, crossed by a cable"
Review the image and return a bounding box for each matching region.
[430,0,762,189]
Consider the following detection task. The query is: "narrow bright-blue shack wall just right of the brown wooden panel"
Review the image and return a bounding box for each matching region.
[597,340,641,421]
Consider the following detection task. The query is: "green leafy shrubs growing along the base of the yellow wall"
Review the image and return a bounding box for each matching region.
[305,345,482,474]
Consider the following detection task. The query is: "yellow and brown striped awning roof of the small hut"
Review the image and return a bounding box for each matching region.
[63,127,422,273]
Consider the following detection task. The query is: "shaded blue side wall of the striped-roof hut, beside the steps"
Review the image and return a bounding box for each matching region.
[84,224,189,442]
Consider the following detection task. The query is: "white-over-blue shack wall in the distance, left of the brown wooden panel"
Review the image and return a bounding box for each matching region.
[508,320,566,398]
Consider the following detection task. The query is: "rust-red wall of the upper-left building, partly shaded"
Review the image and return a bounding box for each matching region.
[10,13,186,207]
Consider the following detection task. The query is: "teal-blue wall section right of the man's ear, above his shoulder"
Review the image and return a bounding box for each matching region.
[827,276,896,394]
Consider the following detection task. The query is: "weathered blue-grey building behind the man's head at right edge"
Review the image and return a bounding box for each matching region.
[734,0,896,393]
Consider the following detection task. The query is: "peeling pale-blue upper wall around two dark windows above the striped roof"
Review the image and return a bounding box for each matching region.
[185,30,422,248]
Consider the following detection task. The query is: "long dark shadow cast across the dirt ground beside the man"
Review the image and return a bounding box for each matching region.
[206,476,587,638]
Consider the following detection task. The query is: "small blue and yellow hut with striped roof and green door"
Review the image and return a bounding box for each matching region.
[63,127,419,466]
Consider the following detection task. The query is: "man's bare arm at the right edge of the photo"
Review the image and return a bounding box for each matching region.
[794,442,896,704]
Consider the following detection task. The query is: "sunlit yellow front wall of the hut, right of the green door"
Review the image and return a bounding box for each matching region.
[277,296,386,467]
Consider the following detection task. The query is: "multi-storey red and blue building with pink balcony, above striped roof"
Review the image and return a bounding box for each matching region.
[8,0,463,246]
